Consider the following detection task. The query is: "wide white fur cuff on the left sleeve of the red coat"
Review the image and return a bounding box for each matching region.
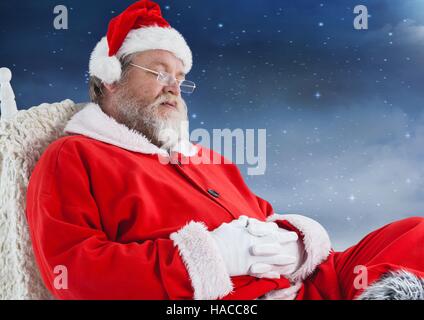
[170,221,233,300]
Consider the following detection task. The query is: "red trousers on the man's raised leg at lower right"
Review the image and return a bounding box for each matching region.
[296,217,424,300]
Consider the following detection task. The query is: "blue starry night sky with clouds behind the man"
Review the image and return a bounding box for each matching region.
[0,0,424,249]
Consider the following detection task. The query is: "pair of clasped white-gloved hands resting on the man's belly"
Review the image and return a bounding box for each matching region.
[211,216,304,278]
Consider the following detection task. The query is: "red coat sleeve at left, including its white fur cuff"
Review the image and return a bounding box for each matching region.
[27,140,232,299]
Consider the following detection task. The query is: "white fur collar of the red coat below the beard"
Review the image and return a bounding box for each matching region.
[64,103,198,157]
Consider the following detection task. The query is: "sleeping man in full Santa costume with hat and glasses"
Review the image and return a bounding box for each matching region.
[27,0,424,299]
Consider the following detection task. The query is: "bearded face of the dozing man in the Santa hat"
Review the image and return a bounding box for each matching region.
[111,50,187,147]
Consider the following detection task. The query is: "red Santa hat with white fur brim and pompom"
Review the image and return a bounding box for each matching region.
[89,0,193,84]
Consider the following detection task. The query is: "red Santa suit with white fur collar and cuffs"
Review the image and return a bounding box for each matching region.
[27,103,424,299]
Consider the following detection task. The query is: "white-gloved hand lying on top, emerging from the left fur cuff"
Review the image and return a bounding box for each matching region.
[211,216,298,277]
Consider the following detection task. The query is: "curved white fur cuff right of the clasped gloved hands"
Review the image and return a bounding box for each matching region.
[267,214,331,283]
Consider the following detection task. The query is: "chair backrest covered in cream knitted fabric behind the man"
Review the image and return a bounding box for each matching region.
[0,100,84,299]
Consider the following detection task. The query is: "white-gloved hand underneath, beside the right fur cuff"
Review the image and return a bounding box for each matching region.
[246,218,305,278]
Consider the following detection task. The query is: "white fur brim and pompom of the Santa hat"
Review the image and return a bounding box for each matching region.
[89,26,193,84]
